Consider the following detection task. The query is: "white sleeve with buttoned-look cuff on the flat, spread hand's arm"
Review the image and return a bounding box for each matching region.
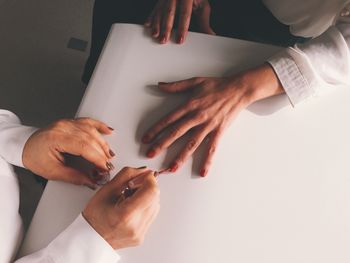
[268,21,350,106]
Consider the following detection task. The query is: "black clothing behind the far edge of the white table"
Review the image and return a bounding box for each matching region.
[82,0,306,83]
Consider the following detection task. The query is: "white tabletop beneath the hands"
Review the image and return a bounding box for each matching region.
[21,24,350,263]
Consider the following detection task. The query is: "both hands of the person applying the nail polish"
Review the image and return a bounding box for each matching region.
[23,118,160,249]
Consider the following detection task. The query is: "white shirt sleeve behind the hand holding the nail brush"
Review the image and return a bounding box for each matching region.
[15,215,120,263]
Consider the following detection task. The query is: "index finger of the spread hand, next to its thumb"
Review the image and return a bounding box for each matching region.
[142,103,193,143]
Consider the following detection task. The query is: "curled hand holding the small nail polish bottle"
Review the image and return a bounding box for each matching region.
[22,118,114,189]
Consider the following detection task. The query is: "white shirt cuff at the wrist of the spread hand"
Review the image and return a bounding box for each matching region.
[267,49,315,107]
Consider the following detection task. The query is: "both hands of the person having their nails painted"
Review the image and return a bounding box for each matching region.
[142,0,284,177]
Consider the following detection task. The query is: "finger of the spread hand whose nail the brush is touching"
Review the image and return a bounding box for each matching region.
[169,126,211,172]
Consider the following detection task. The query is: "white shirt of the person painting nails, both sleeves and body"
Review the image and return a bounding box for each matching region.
[0,110,119,263]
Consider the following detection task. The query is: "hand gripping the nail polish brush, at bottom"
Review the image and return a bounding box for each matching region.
[83,167,160,249]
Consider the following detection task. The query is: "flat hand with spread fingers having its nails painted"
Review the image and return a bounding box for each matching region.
[142,64,283,177]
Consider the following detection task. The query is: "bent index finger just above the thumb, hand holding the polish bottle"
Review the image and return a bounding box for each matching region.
[57,135,113,171]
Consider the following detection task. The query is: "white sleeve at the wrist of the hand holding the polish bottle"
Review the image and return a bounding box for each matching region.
[0,109,36,167]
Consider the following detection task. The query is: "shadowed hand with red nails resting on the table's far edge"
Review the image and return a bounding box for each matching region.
[145,0,215,44]
